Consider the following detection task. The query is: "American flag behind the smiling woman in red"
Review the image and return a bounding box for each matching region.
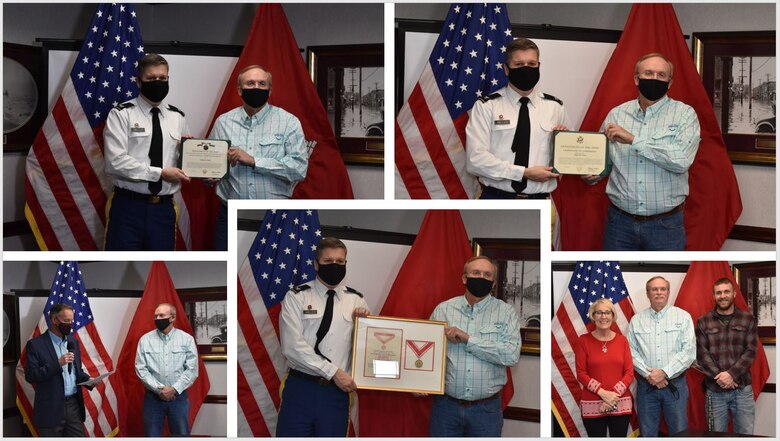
[552,262,638,437]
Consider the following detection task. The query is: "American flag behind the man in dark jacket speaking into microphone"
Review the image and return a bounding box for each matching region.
[16,262,119,437]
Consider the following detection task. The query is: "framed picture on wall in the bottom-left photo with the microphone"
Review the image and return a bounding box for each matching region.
[179,286,228,361]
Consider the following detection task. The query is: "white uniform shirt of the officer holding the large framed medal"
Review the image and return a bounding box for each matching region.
[279,279,368,379]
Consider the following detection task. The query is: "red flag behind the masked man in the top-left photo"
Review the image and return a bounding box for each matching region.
[209,3,354,199]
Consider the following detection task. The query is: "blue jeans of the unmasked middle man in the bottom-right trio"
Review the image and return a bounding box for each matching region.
[636,375,688,438]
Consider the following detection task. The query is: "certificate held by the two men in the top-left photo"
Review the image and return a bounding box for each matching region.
[180,138,230,179]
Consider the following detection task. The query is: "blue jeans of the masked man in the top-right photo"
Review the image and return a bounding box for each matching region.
[604,205,686,251]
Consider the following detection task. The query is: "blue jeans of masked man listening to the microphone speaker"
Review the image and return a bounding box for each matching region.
[144,390,190,438]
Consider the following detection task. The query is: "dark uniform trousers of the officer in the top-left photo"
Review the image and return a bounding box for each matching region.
[105,188,178,251]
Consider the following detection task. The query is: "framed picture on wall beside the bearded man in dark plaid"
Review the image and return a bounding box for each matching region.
[734,262,777,345]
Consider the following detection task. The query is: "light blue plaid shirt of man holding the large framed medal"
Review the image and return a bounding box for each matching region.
[431,295,520,401]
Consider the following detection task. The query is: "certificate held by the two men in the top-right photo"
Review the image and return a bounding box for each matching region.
[552,130,609,175]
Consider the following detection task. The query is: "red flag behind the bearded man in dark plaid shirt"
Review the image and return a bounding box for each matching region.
[674,262,769,430]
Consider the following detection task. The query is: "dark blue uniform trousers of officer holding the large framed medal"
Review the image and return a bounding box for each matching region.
[276,375,349,438]
